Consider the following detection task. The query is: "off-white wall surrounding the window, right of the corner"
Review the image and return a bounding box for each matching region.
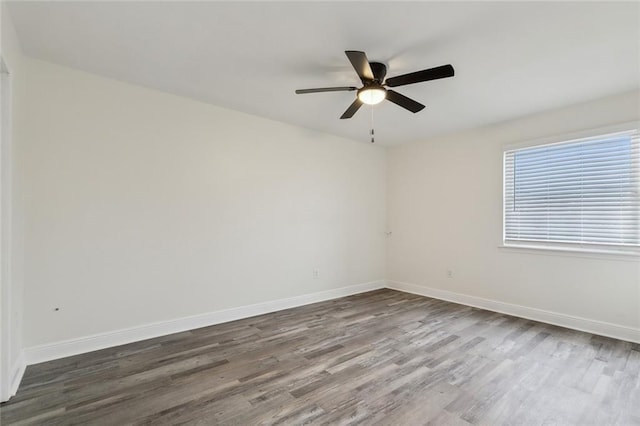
[387,92,640,336]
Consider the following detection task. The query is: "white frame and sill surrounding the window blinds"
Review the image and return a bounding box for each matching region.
[499,120,640,261]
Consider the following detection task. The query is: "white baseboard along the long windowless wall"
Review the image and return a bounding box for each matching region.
[24,280,386,365]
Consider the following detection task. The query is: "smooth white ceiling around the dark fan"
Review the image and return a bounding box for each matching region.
[9,1,640,145]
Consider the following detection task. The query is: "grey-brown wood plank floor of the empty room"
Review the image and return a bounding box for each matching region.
[0,290,640,426]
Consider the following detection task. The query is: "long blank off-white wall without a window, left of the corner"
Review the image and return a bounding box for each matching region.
[24,59,386,347]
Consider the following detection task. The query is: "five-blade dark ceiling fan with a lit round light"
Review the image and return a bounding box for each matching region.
[296,50,454,119]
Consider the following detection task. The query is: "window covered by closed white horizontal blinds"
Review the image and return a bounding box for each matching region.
[504,130,640,253]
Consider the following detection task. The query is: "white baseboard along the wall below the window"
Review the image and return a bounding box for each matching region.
[387,281,640,343]
